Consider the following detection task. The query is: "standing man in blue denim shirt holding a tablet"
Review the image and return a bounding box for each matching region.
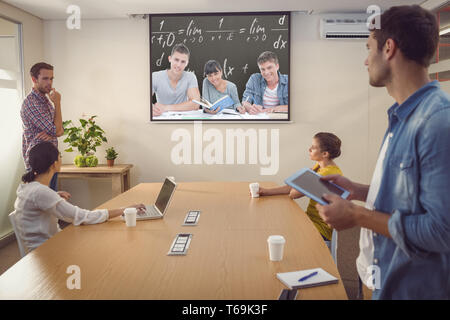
[317,6,450,299]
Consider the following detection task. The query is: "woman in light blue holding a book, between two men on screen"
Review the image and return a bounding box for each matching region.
[202,60,245,114]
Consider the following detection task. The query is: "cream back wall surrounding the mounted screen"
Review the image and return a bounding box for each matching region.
[44,13,393,208]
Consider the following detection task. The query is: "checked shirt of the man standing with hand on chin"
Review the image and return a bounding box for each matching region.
[20,88,58,171]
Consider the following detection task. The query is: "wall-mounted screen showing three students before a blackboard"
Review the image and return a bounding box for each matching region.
[149,12,290,121]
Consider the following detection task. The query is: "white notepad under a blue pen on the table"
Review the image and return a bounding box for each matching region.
[277,268,338,289]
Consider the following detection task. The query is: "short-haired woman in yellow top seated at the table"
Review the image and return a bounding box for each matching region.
[259,132,342,245]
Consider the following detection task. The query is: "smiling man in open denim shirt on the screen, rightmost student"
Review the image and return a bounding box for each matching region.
[242,51,289,114]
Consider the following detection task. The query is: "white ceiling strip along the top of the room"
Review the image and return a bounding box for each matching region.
[0,0,428,20]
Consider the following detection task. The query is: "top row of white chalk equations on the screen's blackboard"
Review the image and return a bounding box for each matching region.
[150,15,289,50]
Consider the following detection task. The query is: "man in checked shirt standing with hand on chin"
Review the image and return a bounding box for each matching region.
[20,62,70,200]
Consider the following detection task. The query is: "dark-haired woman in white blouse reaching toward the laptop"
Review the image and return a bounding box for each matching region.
[14,142,145,251]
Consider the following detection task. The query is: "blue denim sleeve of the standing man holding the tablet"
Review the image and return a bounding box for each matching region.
[388,106,450,257]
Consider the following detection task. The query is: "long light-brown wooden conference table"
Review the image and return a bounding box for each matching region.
[0,182,347,300]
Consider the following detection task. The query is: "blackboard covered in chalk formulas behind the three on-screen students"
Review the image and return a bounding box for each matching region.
[149,12,291,94]
